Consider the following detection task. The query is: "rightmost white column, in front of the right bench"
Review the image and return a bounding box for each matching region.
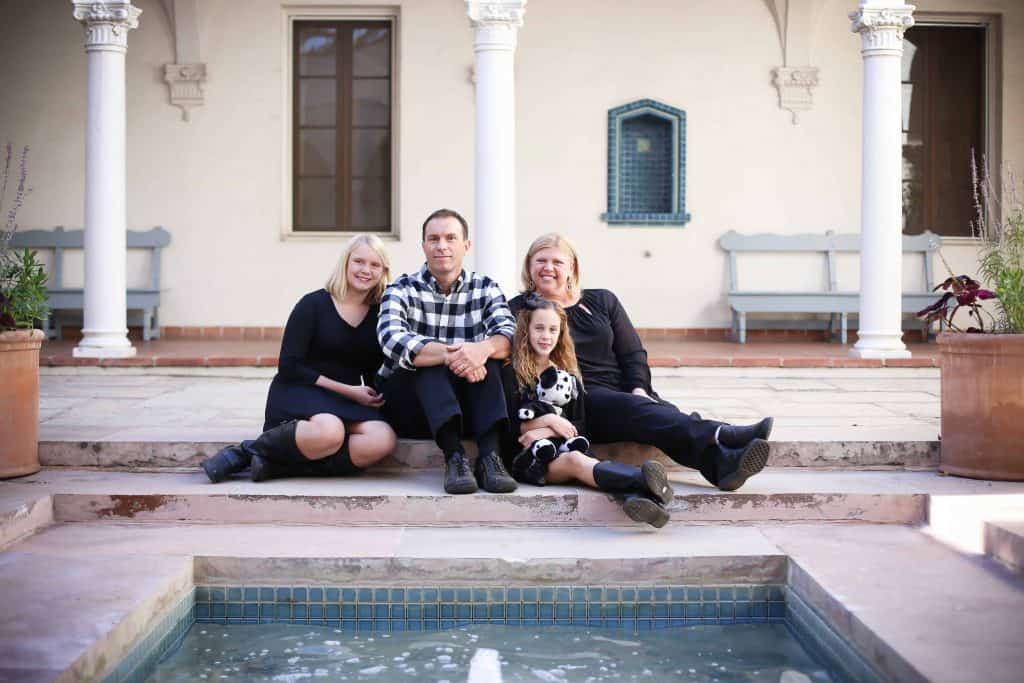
[850,0,913,358]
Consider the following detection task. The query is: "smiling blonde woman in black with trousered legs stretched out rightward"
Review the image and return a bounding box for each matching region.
[509,232,772,490]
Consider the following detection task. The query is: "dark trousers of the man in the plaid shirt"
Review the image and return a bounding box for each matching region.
[381,359,508,438]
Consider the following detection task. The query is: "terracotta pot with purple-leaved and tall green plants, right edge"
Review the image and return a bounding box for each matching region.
[919,160,1024,481]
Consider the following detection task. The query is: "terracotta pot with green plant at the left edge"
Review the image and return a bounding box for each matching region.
[0,143,46,479]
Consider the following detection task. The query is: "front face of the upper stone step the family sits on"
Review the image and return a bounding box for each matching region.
[39,437,939,470]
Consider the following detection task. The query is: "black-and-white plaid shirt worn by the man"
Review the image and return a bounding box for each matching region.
[377,264,515,379]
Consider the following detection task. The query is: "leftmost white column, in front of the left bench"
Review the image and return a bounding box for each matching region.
[73,0,141,358]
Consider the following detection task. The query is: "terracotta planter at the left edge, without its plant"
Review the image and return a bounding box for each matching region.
[0,330,43,479]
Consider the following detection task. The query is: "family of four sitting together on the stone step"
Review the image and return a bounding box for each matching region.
[195,209,772,526]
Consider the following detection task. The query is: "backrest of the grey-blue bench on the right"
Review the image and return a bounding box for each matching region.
[718,230,942,292]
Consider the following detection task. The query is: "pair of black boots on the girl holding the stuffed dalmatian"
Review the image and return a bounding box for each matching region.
[594,460,675,528]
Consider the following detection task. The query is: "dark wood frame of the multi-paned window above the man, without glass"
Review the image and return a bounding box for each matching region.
[289,17,396,234]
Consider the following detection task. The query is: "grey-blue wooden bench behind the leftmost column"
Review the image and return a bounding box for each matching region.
[11,227,171,340]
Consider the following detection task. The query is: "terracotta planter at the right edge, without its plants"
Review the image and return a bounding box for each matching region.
[939,333,1024,481]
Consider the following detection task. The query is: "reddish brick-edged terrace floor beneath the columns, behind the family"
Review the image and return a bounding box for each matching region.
[40,336,939,368]
